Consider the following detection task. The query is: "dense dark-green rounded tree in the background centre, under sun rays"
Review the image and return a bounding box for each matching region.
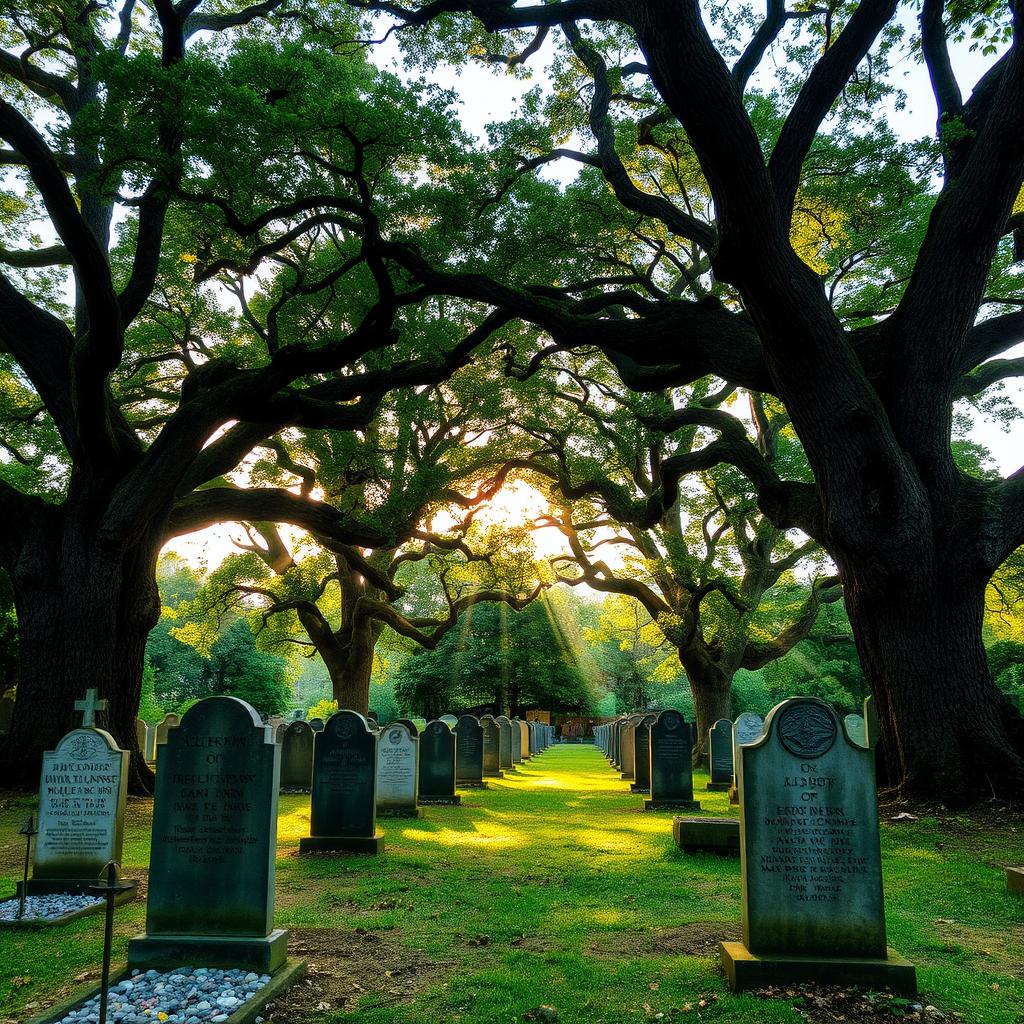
[395,592,595,718]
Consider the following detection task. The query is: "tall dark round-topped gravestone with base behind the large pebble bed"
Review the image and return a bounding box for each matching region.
[128,696,288,973]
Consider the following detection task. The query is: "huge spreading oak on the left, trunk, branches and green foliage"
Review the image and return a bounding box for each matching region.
[0,6,508,788]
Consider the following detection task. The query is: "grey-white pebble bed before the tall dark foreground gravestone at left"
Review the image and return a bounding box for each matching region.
[59,967,270,1024]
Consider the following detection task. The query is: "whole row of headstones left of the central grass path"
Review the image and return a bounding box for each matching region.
[24,690,554,972]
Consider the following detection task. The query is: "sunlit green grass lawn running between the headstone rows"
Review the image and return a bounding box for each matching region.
[0,745,1024,1024]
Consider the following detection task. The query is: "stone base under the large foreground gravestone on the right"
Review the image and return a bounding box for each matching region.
[719,942,918,995]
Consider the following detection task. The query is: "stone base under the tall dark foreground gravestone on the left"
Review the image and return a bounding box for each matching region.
[128,928,288,974]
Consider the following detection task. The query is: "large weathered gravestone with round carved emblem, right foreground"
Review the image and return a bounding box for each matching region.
[721,697,915,992]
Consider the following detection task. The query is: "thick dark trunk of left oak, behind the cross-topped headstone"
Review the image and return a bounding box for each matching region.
[0,513,160,793]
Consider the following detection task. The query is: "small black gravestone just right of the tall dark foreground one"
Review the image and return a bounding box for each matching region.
[299,711,383,854]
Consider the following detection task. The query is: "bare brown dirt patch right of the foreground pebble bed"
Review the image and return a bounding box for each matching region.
[264,928,453,1024]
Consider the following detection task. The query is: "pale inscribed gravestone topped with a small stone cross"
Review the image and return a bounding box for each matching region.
[18,689,135,902]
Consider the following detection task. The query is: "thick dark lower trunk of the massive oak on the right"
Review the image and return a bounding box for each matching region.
[844,565,1024,807]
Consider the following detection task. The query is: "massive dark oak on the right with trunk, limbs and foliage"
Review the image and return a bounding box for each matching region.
[333,0,1024,802]
